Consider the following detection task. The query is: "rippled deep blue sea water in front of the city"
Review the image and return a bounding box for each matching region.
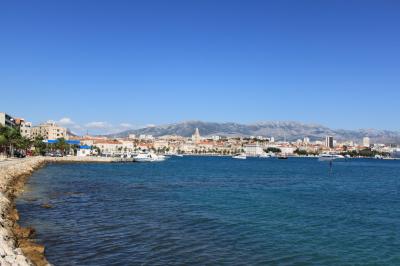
[17,157,400,265]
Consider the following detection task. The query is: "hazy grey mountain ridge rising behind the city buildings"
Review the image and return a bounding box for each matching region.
[108,121,400,144]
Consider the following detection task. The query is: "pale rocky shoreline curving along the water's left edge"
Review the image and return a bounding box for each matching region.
[0,157,125,266]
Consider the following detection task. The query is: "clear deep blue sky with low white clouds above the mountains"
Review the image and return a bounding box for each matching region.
[0,0,400,133]
